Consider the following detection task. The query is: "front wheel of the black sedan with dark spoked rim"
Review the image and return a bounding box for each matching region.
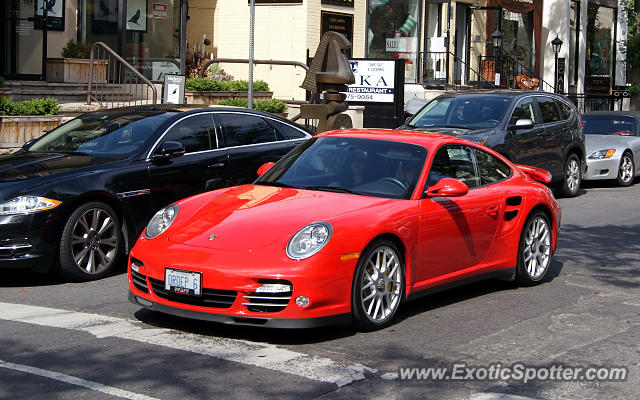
[59,202,123,282]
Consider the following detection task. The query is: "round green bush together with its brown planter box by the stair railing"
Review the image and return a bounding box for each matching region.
[47,40,107,83]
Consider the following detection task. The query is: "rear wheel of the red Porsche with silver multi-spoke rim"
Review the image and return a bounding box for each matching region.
[516,211,553,286]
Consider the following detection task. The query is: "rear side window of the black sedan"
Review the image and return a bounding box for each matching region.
[216,113,277,147]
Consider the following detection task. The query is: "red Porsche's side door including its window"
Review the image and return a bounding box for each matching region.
[416,145,504,283]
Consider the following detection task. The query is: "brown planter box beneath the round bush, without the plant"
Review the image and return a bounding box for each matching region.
[47,58,109,83]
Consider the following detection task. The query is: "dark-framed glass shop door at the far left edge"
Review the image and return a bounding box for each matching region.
[0,0,44,79]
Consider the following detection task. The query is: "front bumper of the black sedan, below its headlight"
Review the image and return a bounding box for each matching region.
[0,213,59,271]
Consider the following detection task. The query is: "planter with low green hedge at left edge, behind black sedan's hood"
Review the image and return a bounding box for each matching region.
[0,97,63,153]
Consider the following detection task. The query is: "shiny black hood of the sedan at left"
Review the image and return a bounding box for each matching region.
[0,153,120,183]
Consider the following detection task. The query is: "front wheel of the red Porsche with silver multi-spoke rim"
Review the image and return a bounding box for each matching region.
[351,240,404,331]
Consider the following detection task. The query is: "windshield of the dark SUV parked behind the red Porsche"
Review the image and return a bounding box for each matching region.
[409,95,511,129]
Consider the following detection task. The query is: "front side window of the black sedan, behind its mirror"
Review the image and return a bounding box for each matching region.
[162,113,218,153]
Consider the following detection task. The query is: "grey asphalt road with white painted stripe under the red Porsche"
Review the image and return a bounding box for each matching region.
[0,183,640,400]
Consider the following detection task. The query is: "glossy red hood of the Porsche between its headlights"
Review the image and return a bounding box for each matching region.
[168,185,397,251]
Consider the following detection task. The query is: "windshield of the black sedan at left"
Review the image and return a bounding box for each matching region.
[28,111,174,156]
